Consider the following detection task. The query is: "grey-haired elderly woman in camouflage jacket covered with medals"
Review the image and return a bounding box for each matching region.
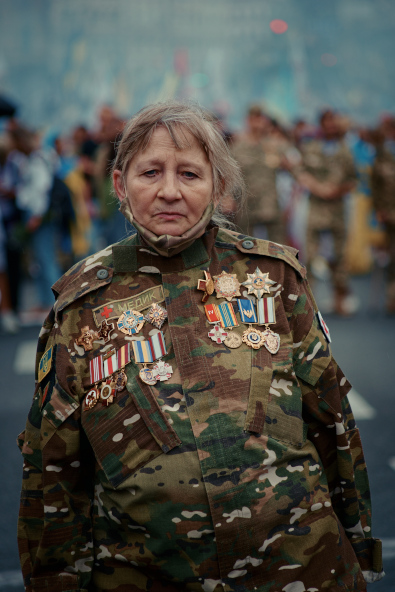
[19,102,382,592]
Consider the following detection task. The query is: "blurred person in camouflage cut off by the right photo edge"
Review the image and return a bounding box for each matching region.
[372,119,395,314]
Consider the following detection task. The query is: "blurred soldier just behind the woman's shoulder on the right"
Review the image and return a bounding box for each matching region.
[232,105,291,244]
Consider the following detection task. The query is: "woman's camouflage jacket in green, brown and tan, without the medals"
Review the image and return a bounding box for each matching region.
[18,228,382,592]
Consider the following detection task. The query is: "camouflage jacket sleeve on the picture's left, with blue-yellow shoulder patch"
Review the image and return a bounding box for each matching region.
[18,313,93,592]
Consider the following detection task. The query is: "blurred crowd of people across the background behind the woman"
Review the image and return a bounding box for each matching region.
[0,105,395,333]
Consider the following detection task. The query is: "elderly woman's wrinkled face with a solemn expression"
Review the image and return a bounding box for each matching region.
[113,127,214,236]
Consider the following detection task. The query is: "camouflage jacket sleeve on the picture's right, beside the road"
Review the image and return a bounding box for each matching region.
[291,281,384,582]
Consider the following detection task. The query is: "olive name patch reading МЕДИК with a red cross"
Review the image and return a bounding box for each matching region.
[92,286,165,327]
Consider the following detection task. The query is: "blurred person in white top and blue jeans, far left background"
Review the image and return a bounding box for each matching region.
[9,126,61,314]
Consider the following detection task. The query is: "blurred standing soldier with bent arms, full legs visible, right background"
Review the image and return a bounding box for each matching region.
[299,110,356,315]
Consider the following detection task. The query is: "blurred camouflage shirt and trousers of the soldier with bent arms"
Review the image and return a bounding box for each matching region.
[301,140,356,293]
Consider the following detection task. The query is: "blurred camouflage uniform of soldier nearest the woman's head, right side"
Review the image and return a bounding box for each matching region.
[232,137,290,243]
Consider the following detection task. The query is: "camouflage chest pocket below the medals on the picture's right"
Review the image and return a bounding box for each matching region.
[245,342,306,447]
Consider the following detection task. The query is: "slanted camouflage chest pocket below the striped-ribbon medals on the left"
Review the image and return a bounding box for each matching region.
[82,364,181,487]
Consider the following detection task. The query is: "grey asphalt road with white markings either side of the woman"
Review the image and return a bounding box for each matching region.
[0,277,395,592]
